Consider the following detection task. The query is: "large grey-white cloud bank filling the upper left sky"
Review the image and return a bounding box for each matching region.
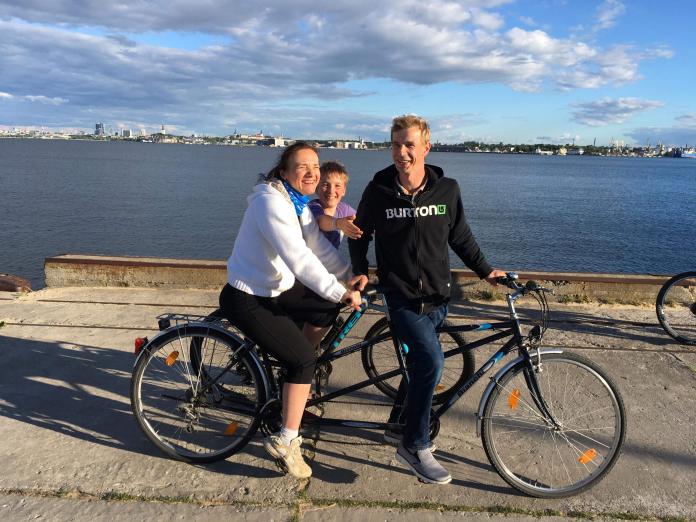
[0,0,669,133]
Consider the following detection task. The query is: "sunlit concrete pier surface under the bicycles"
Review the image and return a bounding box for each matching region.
[0,261,696,522]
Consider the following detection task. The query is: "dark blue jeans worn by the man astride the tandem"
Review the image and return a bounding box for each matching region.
[387,295,447,450]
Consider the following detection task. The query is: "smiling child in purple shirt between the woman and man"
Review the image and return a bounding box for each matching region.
[309,161,362,248]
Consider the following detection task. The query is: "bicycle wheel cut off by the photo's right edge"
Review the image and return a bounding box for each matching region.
[655,272,696,346]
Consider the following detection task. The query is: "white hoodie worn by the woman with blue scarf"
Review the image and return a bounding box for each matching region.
[227,180,352,303]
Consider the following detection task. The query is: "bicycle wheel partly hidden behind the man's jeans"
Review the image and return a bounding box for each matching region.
[362,317,476,405]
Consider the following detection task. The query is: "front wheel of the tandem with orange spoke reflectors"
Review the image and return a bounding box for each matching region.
[481,353,626,498]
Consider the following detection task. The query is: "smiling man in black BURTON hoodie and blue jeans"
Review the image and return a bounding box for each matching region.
[348,115,505,484]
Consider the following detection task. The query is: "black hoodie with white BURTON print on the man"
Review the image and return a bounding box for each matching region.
[348,165,492,305]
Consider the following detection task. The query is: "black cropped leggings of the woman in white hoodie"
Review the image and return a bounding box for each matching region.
[220,281,341,384]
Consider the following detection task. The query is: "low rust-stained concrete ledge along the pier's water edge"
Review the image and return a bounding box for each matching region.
[44,254,670,304]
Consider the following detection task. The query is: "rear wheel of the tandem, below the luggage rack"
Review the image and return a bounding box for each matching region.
[130,325,269,463]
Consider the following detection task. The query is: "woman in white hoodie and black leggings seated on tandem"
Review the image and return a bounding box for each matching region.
[220,142,367,478]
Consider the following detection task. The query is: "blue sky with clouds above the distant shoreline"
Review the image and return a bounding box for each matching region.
[0,0,696,146]
